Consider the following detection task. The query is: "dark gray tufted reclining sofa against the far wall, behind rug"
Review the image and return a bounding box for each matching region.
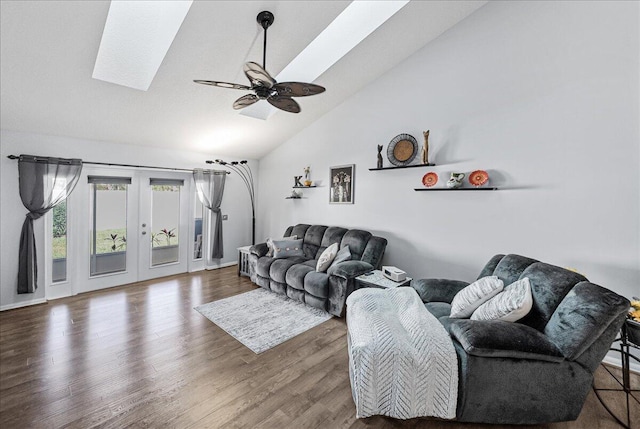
[249,224,387,317]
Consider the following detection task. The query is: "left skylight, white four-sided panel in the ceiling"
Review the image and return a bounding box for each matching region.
[92,0,193,91]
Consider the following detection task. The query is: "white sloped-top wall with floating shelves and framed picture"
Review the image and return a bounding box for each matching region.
[257,1,640,297]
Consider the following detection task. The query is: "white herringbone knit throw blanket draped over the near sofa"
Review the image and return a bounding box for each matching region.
[347,287,458,419]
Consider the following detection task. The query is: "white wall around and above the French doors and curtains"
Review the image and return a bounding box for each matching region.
[0,130,257,309]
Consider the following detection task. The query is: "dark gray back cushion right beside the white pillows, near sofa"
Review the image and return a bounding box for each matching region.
[519,262,587,331]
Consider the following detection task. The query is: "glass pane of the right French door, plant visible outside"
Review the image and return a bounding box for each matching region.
[151,185,181,267]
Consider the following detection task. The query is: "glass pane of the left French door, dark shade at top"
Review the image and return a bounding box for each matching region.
[89,182,128,276]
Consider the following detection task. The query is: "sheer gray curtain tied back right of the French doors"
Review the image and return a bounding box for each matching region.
[193,168,227,259]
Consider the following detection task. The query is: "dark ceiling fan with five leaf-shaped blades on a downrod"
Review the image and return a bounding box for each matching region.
[194,11,325,113]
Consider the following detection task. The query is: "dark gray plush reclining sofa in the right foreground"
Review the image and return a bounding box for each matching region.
[411,255,629,424]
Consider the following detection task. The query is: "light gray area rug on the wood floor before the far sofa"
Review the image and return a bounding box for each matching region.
[195,289,332,354]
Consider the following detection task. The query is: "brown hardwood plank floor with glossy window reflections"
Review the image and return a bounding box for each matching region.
[0,267,640,428]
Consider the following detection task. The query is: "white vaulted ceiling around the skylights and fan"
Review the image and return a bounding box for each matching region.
[0,0,486,159]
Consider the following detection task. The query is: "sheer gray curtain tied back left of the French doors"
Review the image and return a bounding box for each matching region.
[18,155,82,293]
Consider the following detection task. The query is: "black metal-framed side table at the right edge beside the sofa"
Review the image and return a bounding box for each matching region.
[593,320,640,429]
